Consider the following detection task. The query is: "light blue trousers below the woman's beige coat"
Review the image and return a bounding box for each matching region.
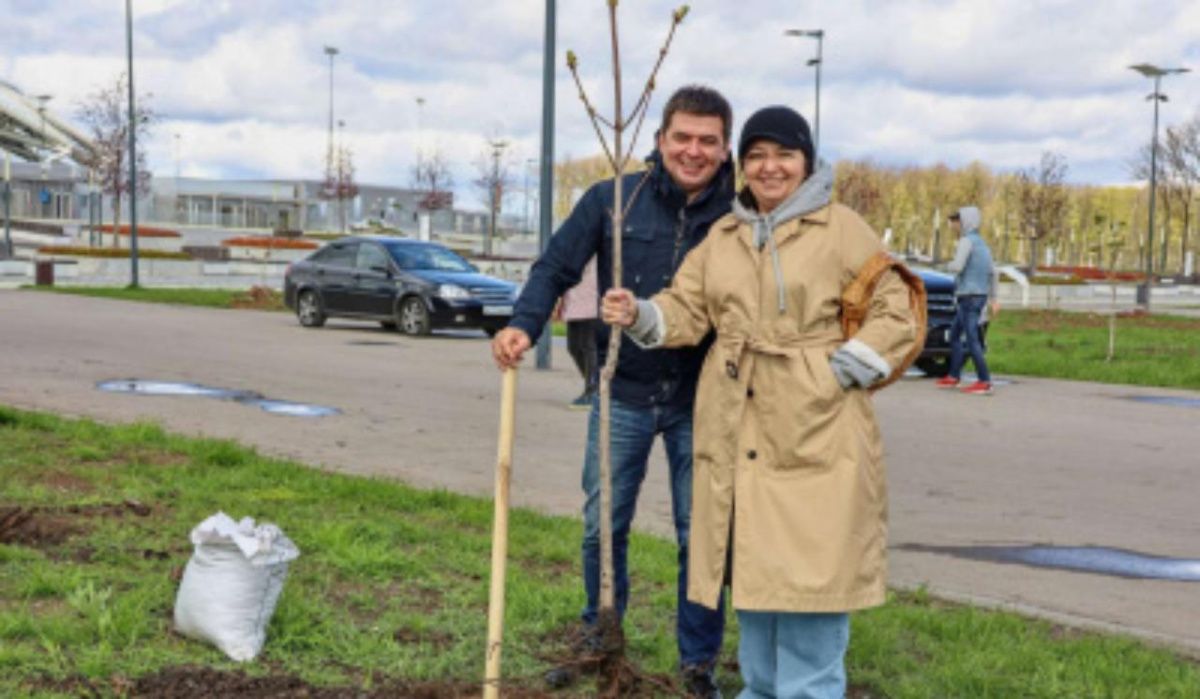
[738,610,850,699]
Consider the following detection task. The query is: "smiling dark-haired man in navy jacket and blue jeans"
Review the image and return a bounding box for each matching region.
[492,85,733,697]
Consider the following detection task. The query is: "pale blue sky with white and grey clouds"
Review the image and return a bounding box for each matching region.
[0,0,1200,207]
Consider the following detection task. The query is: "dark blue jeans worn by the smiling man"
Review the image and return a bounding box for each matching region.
[582,399,725,665]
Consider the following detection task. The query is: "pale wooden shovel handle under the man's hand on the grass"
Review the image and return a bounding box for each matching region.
[484,368,517,699]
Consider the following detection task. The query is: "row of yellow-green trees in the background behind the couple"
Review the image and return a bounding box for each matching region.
[554,113,1200,275]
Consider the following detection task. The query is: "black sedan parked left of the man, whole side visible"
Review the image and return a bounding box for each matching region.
[283,235,517,335]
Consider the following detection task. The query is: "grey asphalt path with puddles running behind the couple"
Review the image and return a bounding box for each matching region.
[7,291,1200,655]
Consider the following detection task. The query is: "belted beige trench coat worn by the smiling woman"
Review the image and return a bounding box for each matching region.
[652,204,918,611]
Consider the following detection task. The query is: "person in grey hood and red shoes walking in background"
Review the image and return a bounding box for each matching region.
[936,207,1000,395]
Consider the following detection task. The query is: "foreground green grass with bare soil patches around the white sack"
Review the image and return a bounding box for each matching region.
[0,407,1200,699]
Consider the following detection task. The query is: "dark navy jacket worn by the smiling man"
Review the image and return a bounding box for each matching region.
[509,151,733,406]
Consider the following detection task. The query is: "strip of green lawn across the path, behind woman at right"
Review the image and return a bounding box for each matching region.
[988,310,1200,390]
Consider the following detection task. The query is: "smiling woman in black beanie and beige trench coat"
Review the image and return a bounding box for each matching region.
[602,107,922,699]
